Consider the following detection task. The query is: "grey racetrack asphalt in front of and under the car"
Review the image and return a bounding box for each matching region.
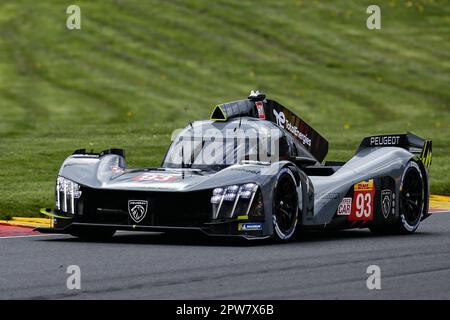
[0,212,450,299]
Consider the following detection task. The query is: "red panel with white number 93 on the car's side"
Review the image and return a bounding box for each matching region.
[348,179,375,222]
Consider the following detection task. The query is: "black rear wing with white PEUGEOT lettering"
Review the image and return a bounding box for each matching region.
[358,132,432,169]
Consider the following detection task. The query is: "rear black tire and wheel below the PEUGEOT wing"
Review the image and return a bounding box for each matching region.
[370,161,427,234]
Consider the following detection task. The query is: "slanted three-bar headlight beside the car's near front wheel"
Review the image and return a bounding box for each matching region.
[211,183,258,219]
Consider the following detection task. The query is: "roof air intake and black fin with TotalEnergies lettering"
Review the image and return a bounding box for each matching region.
[211,92,328,162]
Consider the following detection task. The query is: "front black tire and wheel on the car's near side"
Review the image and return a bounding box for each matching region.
[272,168,299,242]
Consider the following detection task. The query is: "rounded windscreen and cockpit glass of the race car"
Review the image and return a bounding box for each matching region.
[163,119,289,169]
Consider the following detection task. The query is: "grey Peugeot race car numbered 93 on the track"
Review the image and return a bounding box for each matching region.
[37,91,432,242]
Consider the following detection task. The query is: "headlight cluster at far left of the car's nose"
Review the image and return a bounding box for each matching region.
[55,177,81,214]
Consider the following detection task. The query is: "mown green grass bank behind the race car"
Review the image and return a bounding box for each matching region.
[0,0,450,216]
